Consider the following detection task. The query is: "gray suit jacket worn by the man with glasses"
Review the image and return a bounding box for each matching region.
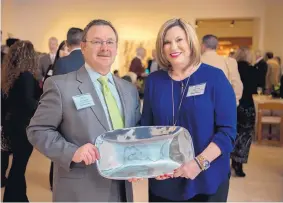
[27,66,140,202]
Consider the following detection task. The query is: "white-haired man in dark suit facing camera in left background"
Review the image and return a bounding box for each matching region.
[38,37,58,81]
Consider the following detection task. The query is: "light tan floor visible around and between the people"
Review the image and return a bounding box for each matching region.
[1,145,283,202]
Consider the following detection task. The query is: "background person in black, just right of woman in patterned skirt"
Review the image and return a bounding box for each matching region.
[254,50,267,92]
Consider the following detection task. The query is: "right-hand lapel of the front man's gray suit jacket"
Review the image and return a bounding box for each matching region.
[113,76,131,128]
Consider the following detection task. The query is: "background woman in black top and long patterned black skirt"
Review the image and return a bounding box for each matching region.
[231,47,258,177]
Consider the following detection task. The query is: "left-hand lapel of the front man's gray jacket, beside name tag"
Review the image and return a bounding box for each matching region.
[77,66,110,131]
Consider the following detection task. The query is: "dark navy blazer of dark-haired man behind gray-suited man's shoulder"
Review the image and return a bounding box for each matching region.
[53,50,85,75]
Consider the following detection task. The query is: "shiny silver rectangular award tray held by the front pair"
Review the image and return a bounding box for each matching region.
[95,126,195,180]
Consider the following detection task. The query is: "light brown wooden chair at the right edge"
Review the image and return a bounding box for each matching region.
[257,102,283,146]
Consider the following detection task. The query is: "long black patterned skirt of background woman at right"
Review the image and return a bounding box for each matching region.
[231,105,255,163]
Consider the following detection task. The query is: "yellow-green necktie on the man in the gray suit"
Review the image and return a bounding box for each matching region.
[98,76,124,130]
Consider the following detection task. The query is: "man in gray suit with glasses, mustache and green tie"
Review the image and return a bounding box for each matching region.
[27,20,140,202]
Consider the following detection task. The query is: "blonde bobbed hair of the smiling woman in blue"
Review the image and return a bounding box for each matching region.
[156,18,200,69]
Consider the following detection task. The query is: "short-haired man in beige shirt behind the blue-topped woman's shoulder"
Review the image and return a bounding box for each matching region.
[201,35,243,105]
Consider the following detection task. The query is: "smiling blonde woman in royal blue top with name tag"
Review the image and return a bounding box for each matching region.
[141,19,237,202]
